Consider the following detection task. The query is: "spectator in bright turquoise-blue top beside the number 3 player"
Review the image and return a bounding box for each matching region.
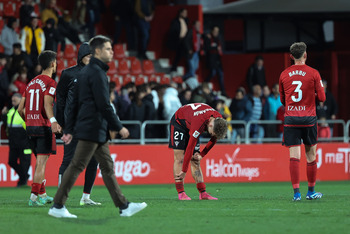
[265,83,282,137]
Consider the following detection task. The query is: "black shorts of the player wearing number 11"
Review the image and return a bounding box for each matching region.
[29,134,56,156]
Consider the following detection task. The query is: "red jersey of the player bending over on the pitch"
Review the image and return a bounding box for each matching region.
[175,103,222,172]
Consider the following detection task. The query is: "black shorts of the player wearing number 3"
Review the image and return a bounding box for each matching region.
[282,124,317,147]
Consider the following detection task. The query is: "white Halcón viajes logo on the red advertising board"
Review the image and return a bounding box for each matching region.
[206,148,260,180]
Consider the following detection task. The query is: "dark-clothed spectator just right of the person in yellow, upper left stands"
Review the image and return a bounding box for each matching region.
[43,18,66,57]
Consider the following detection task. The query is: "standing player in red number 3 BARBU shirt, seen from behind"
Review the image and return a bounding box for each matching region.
[279,42,326,201]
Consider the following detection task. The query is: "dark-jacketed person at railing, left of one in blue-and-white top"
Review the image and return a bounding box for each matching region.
[230,87,253,144]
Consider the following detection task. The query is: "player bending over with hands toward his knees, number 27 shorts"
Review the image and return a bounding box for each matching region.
[169,103,227,200]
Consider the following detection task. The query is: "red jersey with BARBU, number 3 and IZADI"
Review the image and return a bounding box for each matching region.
[279,65,326,126]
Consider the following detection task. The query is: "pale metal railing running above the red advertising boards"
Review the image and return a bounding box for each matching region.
[0,119,350,145]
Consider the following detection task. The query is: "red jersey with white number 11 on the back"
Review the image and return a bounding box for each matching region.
[23,75,56,130]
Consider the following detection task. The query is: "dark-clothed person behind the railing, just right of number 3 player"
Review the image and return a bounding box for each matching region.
[316,80,338,136]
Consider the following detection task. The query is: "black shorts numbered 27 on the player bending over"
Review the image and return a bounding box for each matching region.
[169,116,200,154]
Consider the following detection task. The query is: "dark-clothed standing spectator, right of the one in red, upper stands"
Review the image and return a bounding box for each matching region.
[204,26,227,96]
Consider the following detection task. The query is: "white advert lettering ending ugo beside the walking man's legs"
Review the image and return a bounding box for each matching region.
[99,154,151,182]
